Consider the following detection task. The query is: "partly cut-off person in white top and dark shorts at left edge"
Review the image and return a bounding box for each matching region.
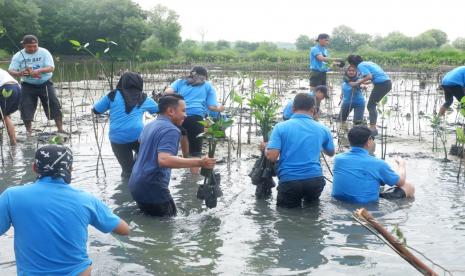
[0,68,21,145]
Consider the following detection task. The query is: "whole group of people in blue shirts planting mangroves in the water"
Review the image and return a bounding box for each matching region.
[0,34,465,275]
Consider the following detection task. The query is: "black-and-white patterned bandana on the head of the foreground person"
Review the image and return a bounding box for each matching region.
[35,145,73,184]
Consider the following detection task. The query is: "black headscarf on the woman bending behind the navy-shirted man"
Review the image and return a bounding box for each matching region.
[108,72,147,114]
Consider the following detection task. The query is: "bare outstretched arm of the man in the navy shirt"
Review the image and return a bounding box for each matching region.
[158,152,216,169]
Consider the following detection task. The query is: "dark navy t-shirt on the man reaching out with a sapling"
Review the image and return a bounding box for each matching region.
[129,115,181,204]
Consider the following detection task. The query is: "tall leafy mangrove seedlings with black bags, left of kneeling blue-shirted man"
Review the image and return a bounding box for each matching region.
[249,82,279,198]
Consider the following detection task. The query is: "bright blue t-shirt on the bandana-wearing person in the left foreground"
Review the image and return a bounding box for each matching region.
[0,177,120,275]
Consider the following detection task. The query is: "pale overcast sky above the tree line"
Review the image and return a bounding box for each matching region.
[133,0,465,42]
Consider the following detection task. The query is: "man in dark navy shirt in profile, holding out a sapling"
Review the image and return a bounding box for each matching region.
[129,94,216,217]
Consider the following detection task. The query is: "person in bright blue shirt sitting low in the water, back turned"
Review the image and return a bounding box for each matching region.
[332,126,415,204]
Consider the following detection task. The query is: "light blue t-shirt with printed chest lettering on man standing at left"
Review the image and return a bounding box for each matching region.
[9,47,55,85]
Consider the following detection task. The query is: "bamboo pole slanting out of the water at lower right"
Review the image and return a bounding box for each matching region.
[354,208,438,276]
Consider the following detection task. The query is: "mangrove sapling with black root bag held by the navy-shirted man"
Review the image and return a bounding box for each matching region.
[197,116,234,208]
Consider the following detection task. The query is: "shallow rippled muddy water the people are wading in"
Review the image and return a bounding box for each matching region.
[0,72,465,275]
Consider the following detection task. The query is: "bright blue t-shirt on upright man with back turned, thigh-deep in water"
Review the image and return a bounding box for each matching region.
[267,114,334,183]
